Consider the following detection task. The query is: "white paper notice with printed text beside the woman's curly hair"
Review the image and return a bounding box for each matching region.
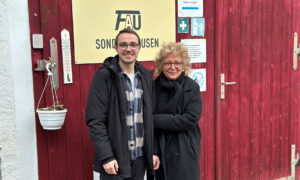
[181,39,206,63]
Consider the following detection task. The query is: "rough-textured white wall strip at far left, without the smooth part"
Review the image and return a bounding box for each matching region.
[0,1,17,180]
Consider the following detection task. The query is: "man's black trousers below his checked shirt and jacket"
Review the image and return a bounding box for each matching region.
[100,157,146,180]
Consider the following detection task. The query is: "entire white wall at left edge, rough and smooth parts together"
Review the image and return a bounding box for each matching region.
[0,0,38,180]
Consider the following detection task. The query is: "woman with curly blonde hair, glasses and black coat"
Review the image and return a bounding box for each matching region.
[153,43,202,180]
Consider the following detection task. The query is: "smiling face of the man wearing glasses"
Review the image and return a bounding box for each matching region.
[115,33,141,64]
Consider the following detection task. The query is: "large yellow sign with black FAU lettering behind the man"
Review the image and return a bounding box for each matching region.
[72,0,176,64]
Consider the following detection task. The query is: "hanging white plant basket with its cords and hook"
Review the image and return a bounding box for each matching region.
[36,60,67,130]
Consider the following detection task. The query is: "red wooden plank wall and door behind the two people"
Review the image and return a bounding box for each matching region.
[28,0,300,180]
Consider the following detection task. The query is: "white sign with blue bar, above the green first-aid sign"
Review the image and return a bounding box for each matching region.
[177,0,203,17]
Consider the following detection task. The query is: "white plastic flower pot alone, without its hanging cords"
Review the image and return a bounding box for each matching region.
[36,108,67,130]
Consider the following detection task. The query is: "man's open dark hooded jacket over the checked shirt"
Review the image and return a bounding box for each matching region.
[86,55,154,178]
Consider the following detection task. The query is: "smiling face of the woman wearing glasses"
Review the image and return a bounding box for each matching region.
[163,54,183,80]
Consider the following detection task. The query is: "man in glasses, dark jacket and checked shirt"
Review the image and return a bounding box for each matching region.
[86,28,160,180]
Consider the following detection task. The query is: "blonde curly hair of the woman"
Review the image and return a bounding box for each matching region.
[154,42,191,76]
